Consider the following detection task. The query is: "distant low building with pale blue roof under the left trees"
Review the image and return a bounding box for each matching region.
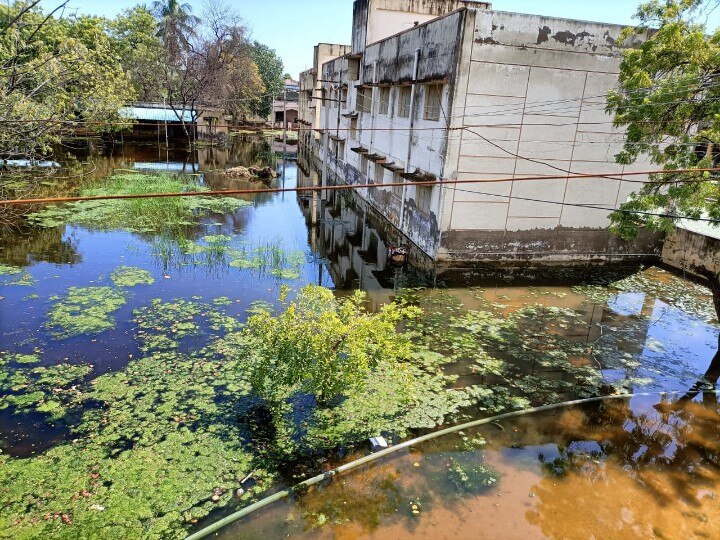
[120,102,228,140]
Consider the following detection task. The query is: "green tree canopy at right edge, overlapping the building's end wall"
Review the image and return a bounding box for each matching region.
[608,0,720,239]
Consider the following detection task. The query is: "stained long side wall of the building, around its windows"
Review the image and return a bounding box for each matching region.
[320,11,466,257]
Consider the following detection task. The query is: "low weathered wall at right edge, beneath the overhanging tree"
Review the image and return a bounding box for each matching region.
[662,228,720,274]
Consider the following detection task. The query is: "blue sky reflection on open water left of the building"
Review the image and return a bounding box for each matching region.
[0,162,333,375]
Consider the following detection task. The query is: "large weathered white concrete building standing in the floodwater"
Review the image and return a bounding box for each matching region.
[300,0,659,265]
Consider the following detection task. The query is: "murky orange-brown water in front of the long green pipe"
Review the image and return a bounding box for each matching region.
[229,394,720,540]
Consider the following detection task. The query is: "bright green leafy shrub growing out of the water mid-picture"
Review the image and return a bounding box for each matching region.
[245,286,416,405]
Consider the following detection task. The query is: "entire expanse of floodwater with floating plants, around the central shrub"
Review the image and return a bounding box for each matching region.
[0,139,720,538]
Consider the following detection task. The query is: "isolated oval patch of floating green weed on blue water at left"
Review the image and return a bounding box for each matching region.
[47,287,126,338]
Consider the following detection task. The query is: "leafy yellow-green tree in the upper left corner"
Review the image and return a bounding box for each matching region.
[0,1,132,159]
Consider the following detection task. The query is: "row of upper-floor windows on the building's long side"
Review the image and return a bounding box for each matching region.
[330,83,444,121]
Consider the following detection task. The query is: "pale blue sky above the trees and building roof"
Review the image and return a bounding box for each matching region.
[56,0,720,77]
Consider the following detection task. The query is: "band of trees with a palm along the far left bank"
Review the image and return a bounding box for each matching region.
[0,0,283,159]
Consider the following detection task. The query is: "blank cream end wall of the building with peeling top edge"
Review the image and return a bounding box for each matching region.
[440,10,654,259]
